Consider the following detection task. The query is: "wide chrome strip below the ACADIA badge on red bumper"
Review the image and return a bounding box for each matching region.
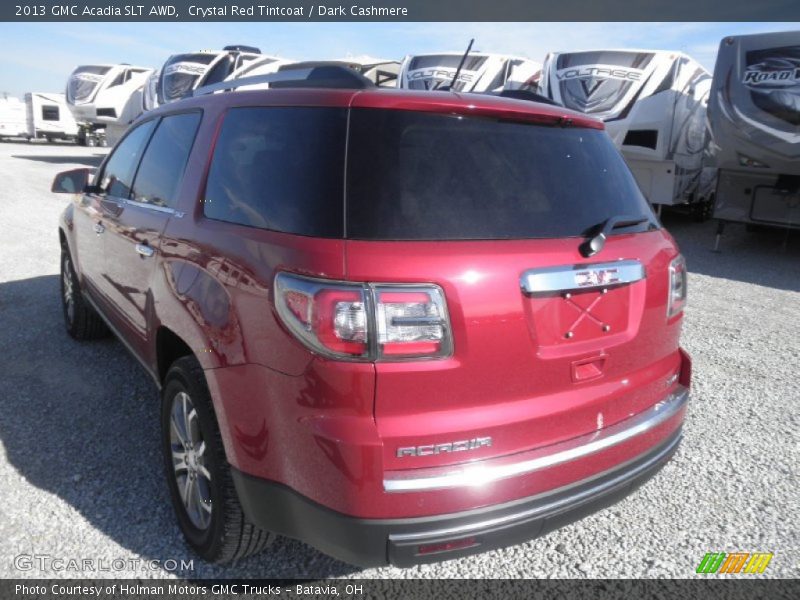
[383,386,689,494]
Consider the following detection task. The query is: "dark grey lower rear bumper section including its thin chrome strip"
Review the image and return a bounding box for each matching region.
[233,428,681,567]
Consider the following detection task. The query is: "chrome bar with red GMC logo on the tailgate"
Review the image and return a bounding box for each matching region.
[519,260,645,294]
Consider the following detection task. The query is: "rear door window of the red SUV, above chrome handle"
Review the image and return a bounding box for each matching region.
[133,112,200,207]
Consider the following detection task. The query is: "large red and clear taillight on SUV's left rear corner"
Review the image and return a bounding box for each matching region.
[275,273,453,361]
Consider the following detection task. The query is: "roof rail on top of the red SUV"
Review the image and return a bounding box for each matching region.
[192,65,375,96]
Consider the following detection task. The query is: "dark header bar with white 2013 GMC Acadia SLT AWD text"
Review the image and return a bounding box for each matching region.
[0,0,800,22]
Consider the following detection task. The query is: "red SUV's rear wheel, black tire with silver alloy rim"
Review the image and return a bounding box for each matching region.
[161,356,276,563]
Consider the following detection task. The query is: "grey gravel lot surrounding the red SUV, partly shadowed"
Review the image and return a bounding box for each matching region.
[0,138,800,578]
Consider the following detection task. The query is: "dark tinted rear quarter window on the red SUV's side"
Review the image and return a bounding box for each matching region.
[204,108,347,237]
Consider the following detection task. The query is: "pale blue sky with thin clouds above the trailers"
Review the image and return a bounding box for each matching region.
[0,23,800,96]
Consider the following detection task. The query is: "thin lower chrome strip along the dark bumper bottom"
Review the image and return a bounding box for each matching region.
[389,434,683,542]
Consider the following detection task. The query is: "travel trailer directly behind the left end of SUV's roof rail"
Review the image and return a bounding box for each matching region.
[155,46,268,108]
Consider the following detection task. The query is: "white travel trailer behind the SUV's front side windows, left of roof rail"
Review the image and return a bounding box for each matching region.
[67,64,153,146]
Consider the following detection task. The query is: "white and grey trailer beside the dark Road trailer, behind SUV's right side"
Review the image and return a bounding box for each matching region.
[539,50,714,213]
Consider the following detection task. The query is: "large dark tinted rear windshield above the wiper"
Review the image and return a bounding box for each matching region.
[347,109,655,240]
